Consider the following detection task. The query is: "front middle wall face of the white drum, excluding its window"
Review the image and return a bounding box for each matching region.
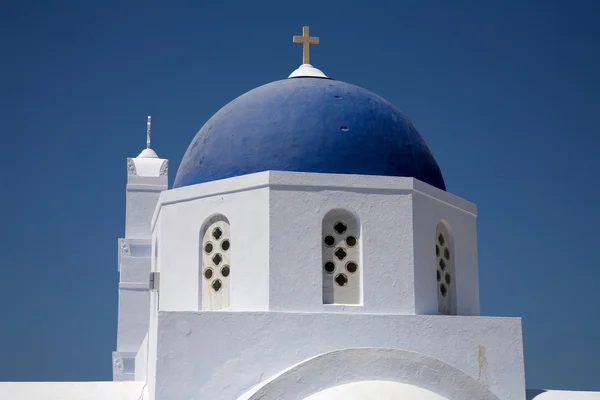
[270,172,414,314]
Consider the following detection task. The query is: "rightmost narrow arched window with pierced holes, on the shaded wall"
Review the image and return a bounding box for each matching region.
[435,221,456,315]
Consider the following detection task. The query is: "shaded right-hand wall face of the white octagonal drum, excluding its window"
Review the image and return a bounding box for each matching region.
[412,181,479,315]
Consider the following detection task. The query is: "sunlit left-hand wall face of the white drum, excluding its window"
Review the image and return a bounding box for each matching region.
[155,175,269,311]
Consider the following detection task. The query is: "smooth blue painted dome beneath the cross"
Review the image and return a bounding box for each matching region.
[174,78,446,190]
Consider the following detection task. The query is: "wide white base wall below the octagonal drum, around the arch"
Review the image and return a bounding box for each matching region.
[156,311,525,400]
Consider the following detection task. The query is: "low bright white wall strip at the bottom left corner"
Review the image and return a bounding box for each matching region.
[0,382,144,400]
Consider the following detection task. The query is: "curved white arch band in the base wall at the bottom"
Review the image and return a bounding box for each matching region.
[238,348,499,400]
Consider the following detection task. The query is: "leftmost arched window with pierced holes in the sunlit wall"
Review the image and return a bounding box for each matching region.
[200,215,231,311]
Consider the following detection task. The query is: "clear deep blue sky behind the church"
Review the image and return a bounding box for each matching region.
[0,0,600,390]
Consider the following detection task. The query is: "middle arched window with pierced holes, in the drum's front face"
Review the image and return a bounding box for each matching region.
[321,210,362,304]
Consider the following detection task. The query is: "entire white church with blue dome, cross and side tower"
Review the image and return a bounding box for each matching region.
[0,27,600,400]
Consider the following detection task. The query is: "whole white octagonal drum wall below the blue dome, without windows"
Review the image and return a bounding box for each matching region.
[153,171,479,315]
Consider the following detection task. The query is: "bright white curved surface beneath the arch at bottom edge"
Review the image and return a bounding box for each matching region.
[306,381,447,400]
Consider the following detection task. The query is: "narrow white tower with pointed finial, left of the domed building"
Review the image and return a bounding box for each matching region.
[113,117,169,381]
